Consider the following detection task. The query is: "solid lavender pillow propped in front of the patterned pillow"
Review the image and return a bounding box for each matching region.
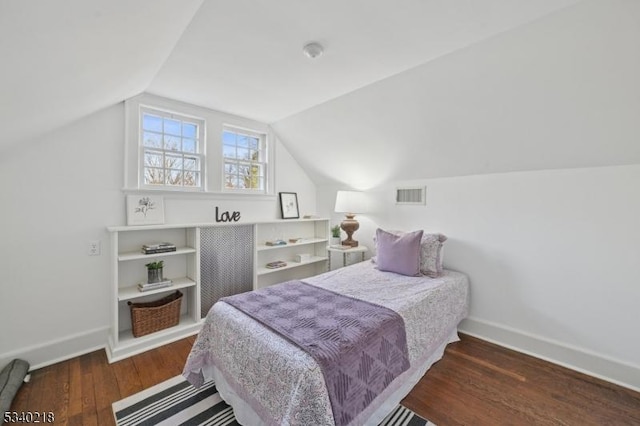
[376,228,423,277]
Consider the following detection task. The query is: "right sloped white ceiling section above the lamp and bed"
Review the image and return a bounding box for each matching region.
[274,0,640,189]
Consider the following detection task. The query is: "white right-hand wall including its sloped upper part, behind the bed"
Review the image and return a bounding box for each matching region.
[274,0,640,389]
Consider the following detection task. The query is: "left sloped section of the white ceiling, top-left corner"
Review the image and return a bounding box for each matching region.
[0,0,202,150]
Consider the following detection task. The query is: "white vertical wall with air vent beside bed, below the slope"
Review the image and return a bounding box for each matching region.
[318,165,640,389]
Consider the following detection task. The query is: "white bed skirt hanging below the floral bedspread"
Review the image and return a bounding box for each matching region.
[205,328,460,426]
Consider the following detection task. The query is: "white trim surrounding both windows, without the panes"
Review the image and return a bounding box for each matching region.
[123,93,275,199]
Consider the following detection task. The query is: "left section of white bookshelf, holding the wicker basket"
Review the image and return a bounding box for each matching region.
[107,225,201,362]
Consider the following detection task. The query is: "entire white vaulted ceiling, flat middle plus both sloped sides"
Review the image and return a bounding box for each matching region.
[0,0,640,185]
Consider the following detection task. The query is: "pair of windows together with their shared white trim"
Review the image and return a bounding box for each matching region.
[124,93,276,195]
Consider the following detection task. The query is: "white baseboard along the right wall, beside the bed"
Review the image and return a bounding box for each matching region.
[458,318,640,392]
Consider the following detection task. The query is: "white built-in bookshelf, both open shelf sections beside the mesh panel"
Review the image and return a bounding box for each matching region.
[107,218,329,362]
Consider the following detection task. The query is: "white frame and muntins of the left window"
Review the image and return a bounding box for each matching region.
[138,105,207,192]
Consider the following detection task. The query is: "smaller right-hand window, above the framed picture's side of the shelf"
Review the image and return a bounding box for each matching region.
[222,126,267,192]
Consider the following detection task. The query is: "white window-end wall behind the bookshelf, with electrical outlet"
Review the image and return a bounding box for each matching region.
[0,104,316,366]
